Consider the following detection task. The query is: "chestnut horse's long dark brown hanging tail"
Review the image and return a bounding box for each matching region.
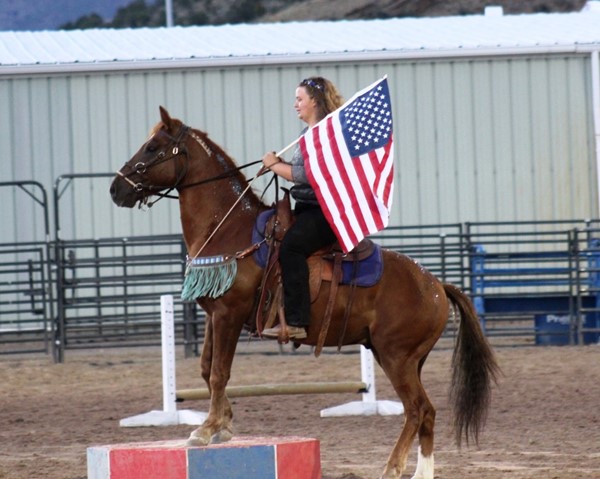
[444,284,499,447]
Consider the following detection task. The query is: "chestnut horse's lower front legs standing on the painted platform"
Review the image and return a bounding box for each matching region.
[188,316,241,446]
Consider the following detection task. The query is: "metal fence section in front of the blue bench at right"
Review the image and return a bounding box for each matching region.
[465,220,600,345]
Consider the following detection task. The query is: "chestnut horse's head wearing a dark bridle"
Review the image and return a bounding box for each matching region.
[110,107,190,208]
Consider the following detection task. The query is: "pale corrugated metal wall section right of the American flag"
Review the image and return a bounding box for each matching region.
[391,57,597,224]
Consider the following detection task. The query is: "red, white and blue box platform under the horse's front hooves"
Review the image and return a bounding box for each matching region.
[87,437,321,479]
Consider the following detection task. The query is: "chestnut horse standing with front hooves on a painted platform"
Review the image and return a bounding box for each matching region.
[110,107,497,479]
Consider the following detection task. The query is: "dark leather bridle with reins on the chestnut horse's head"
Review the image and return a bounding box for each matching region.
[117,125,260,208]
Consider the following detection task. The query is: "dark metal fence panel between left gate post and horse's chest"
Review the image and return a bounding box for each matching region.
[54,235,204,361]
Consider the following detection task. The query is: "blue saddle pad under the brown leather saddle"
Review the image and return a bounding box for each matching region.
[252,209,383,287]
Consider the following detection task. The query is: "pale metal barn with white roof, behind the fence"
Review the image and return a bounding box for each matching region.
[0,7,600,241]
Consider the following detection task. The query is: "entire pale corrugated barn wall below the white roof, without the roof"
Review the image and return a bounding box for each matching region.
[0,55,598,243]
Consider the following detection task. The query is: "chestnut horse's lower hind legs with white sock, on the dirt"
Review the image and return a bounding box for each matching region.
[381,357,435,479]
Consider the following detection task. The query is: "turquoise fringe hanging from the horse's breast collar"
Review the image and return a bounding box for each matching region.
[181,258,237,301]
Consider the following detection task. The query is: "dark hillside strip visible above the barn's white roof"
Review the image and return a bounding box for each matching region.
[0,0,597,31]
